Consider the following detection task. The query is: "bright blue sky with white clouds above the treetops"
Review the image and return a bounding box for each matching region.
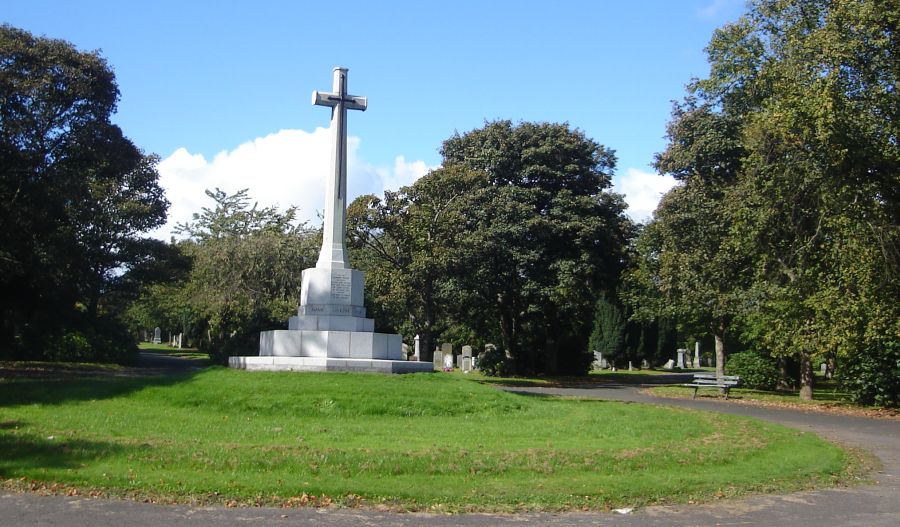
[0,0,744,236]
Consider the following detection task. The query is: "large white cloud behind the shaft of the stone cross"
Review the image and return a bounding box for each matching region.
[150,128,430,240]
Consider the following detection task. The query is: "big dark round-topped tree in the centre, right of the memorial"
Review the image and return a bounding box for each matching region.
[441,121,631,373]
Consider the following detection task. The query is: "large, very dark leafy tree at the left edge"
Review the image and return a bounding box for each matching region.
[0,25,168,356]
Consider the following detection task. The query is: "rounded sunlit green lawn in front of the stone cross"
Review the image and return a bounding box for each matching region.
[0,368,859,511]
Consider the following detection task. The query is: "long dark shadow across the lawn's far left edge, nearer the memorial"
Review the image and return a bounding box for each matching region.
[0,371,198,408]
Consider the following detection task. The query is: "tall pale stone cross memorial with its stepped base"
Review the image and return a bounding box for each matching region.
[228,68,432,373]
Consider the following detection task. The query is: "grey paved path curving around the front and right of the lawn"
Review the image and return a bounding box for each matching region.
[0,374,900,527]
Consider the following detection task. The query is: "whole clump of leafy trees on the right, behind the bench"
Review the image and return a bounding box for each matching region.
[624,0,900,404]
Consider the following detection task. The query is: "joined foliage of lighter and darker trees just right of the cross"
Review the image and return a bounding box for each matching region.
[348,121,632,373]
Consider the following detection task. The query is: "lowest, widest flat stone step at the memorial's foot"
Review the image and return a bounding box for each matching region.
[228,357,434,373]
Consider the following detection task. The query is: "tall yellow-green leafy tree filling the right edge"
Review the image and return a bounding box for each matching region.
[636,0,900,397]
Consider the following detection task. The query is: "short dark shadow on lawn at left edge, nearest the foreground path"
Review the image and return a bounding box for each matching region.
[0,432,123,478]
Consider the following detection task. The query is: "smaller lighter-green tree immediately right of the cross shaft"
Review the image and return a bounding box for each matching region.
[347,166,481,360]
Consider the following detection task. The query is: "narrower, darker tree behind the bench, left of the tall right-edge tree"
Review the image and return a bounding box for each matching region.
[624,103,749,375]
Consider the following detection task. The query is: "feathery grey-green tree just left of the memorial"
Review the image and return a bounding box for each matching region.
[174,189,321,361]
